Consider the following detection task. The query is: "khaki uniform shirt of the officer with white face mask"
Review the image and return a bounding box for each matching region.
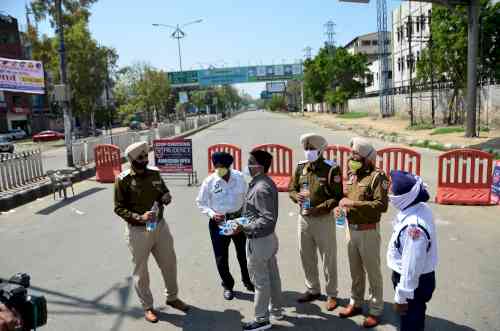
[288,157,343,212]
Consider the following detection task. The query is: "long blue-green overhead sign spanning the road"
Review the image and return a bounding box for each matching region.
[168,63,304,87]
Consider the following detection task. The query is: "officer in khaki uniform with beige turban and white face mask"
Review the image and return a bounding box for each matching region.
[289,133,343,311]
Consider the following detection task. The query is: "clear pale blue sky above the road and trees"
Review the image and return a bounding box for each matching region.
[0,0,400,96]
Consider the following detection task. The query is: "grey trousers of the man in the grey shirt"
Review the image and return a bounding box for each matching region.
[247,233,282,322]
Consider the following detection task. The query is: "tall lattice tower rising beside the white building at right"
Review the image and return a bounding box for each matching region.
[377,0,394,117]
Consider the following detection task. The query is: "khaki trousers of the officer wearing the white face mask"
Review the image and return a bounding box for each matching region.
[298,213,338,298]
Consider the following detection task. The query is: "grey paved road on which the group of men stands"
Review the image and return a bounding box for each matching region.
[0,112,500,331]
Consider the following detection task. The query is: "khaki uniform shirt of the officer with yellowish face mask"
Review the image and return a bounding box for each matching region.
[347,168,389,224]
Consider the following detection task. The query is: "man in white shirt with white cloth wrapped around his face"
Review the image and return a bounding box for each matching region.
[387,171,437,331]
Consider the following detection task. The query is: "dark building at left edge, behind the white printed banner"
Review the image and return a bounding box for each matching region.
[0,14,32,133]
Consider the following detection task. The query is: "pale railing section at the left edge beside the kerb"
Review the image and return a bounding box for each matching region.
[0,150,44,192]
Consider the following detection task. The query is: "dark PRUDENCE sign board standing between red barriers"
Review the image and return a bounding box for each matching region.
[153,139,193,173]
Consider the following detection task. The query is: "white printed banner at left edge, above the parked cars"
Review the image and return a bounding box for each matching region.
[0,57,45,94]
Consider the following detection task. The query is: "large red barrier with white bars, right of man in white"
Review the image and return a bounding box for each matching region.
[436,149,493,205]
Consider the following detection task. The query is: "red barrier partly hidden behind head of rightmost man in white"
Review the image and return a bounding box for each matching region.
[377,147,421,176]
